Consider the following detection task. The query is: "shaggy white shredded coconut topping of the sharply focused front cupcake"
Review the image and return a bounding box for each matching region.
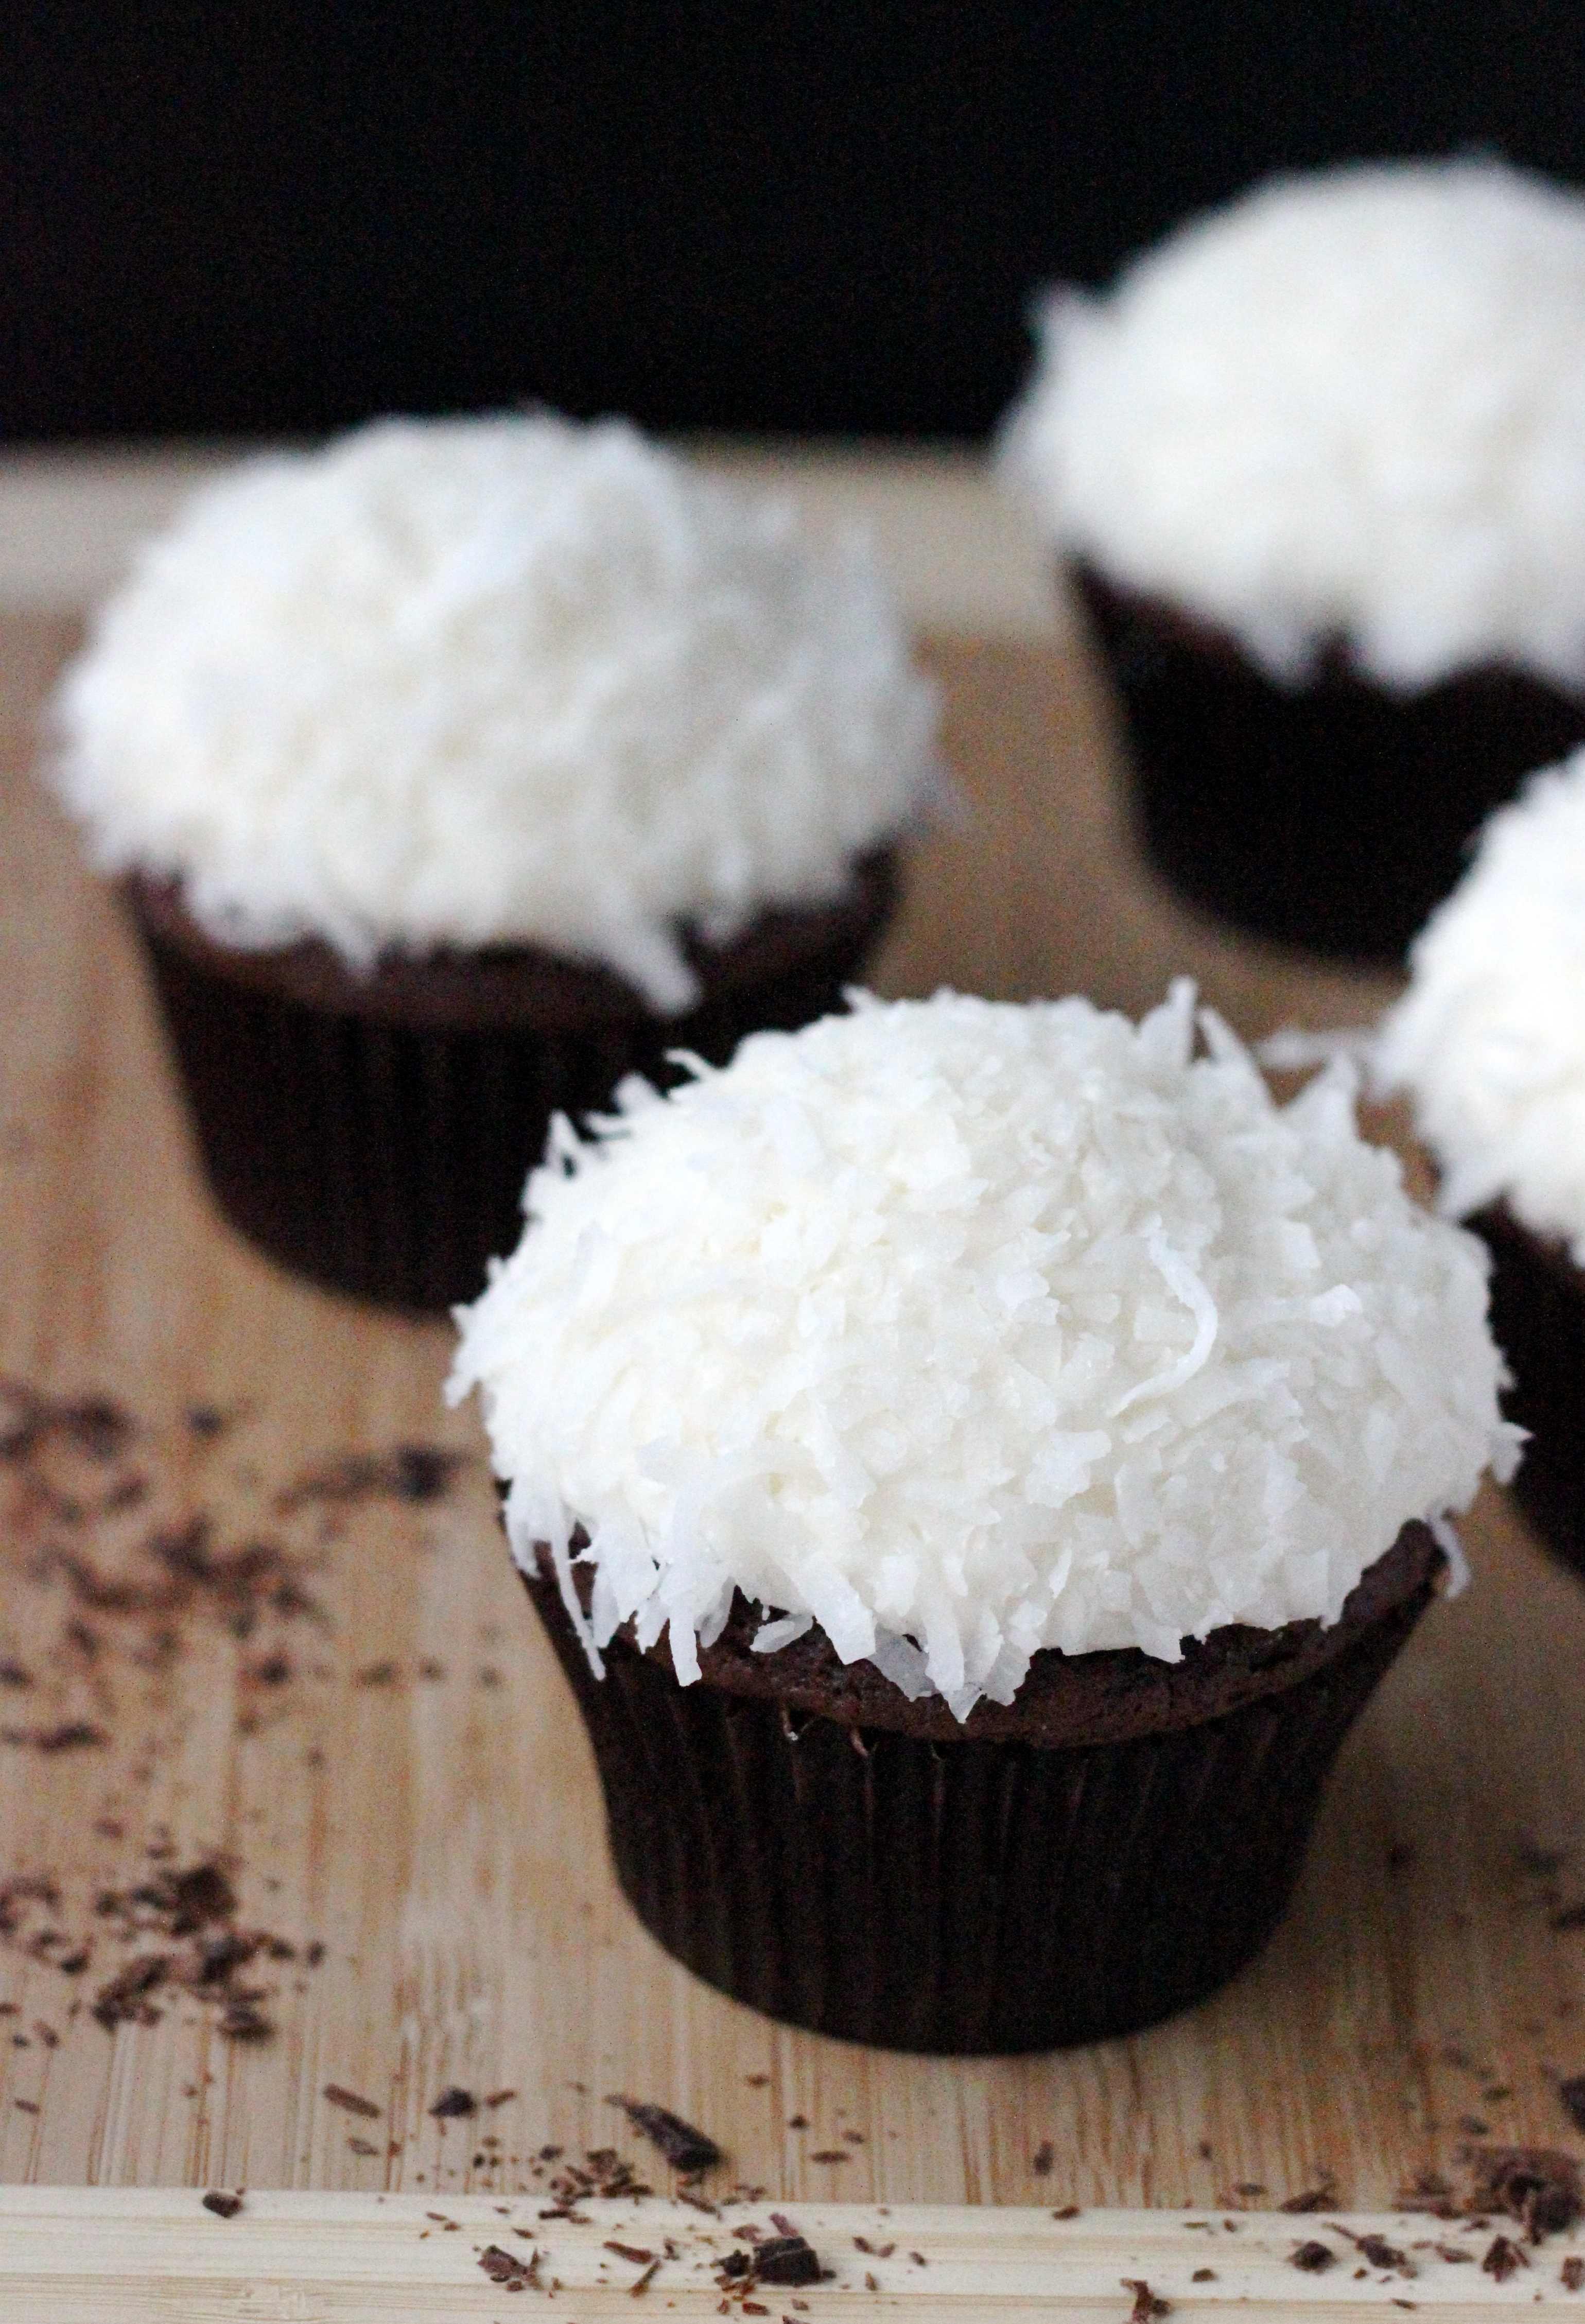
[448,983,1511,1718]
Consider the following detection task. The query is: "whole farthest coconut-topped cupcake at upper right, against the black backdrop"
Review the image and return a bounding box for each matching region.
[1006,160,1585,960]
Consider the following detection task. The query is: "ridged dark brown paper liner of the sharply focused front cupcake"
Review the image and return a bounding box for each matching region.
[528,1562,1432,2054]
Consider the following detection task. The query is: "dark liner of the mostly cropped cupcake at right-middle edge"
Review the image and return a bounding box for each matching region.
[1467,1204,1585,1573]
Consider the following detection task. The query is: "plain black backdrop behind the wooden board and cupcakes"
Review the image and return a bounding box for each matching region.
[12,0,1585,437]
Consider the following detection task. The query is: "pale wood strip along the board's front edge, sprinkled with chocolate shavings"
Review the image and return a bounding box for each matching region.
[0,2187,1585,2324]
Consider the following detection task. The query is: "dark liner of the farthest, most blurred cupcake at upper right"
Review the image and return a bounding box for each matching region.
[1071,565,1585,960]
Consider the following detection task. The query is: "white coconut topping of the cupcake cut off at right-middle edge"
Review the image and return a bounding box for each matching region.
[1373,751,1585,1267]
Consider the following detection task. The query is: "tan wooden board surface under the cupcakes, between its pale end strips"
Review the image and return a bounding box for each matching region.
[0,448,1585,2268]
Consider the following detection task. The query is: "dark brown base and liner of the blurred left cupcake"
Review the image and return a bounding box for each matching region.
[128,858,895,1311]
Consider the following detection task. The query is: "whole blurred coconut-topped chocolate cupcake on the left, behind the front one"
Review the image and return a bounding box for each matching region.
[51,416,939,1308]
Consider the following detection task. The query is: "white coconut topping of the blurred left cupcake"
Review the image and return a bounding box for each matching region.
[56,416,939,1011]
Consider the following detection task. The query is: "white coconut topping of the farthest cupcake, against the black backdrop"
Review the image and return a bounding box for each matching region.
[1006,160,1585,690]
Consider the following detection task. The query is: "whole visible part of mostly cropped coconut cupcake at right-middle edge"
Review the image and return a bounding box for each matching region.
[1376,751,1585,1571]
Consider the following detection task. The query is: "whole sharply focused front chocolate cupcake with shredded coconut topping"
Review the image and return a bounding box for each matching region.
[451,985,1511,2052]
